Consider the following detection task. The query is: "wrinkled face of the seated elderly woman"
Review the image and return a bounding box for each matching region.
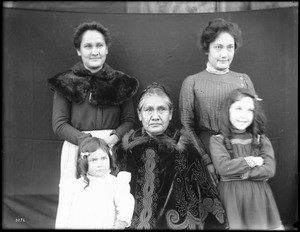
[138,95,172,135]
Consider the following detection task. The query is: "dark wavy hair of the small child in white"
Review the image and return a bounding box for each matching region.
[76,139,115,189]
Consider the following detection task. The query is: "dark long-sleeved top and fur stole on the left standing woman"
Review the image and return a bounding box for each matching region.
[48,62,139,145]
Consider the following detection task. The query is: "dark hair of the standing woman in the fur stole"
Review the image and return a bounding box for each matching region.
[73,21,111,49]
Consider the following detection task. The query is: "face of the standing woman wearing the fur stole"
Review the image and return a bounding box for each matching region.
[77,30,108,73]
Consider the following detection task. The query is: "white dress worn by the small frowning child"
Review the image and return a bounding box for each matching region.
[56,172,134,229]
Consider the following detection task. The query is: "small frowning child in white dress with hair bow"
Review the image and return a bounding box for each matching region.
[56,139,134,229]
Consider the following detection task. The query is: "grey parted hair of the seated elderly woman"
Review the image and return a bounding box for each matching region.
[137,82,173,112]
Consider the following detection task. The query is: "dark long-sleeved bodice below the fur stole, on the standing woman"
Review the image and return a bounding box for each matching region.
[52,92,135,145]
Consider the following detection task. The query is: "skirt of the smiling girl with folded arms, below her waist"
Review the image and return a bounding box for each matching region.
[218,180,281,230]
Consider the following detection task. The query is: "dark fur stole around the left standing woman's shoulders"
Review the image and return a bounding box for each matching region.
[48,62,139,106]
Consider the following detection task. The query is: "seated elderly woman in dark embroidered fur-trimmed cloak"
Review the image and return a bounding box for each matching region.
[113,83,227,229]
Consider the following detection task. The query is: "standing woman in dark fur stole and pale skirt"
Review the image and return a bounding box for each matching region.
[48,22,139,229]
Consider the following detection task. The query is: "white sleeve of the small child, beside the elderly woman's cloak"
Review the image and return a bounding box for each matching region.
[115,171,134,227]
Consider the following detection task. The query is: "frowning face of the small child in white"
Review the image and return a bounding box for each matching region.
[88,149,110,177]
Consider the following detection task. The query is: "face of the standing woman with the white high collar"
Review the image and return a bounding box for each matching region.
[208,32,235,70]
